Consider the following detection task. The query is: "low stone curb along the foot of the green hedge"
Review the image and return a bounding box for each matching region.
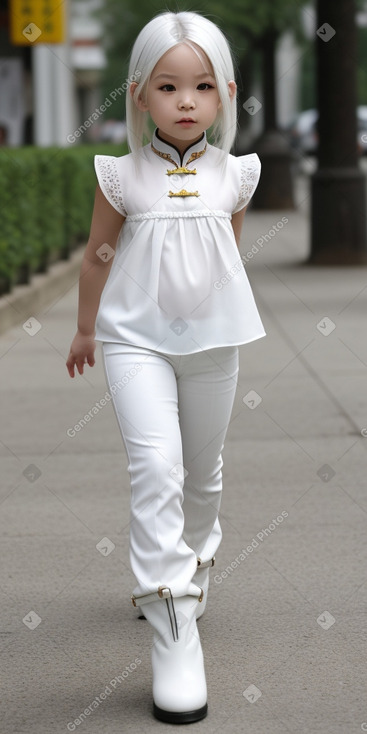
[0,244,85,334]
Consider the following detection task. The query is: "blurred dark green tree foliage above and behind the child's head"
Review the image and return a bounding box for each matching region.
[101,0,303,137]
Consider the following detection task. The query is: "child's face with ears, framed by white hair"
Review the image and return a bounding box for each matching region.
[130,43,236,152]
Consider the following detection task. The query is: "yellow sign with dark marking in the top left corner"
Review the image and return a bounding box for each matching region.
[10,0,66,46]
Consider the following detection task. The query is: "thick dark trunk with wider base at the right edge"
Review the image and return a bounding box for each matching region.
[309,0,367,265]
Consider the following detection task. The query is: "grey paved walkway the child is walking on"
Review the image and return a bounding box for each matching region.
[0,177,367,734]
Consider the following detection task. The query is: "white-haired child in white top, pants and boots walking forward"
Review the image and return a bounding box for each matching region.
[67,12,265,724]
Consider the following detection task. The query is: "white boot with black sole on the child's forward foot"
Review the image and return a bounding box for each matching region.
[132,584,208,724]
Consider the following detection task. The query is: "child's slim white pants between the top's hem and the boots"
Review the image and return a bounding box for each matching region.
[102,342,239,596]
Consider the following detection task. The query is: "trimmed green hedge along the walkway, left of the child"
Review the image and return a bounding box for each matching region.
[0,143,128,295]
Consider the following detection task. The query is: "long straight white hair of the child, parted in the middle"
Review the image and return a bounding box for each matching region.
[126,11,237,157]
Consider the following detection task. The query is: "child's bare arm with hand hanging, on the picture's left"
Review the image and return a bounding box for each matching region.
[66,186,125,377]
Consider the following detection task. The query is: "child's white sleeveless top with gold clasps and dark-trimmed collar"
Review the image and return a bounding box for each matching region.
[95,130,266,354]
